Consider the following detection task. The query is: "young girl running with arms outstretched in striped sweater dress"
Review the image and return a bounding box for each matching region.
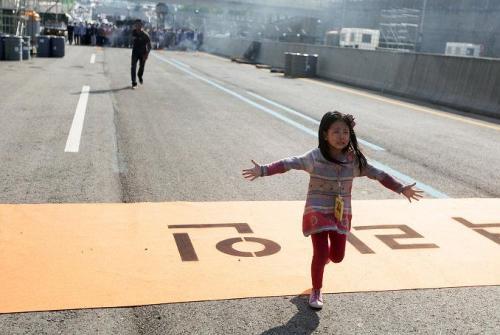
[243,112,423,309]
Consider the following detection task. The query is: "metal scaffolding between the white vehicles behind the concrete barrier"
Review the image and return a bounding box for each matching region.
[379,8,422,52]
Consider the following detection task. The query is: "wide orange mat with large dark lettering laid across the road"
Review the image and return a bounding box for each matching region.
[0,199,500,313]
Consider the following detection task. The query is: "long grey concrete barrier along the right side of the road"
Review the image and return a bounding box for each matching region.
[205,37,500,118]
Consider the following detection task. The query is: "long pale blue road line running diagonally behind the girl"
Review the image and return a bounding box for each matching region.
[153,53,448,198]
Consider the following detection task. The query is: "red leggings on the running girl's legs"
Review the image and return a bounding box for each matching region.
[311,231,347,290]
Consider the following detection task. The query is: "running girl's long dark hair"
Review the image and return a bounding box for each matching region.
[318,111,367,170]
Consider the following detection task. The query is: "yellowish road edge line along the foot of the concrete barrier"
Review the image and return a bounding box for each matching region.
[301,78,500,130]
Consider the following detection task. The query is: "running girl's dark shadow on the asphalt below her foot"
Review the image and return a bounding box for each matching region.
[261,295,319,335]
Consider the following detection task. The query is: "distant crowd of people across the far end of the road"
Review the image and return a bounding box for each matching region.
[67,22,203,50]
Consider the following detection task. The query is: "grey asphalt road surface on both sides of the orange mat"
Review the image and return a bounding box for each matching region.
[0,46,500,334]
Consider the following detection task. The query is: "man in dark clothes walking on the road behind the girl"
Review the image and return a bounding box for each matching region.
[131,20,151,88]
